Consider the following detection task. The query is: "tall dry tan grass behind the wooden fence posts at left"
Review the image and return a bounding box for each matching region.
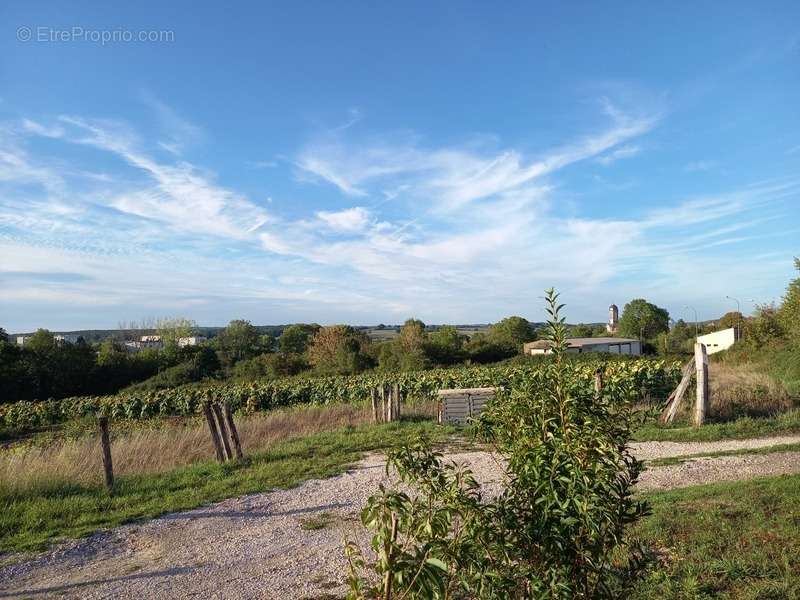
[0,405,433,493]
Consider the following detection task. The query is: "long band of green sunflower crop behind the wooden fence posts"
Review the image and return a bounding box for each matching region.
[0,358,680,429]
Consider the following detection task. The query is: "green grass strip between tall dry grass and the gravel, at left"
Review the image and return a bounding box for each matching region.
[0,420,455,552]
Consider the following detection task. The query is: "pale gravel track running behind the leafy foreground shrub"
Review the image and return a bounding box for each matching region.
[0,436,800,600]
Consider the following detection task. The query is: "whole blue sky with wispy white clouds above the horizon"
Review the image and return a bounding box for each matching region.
[0,1,800,331]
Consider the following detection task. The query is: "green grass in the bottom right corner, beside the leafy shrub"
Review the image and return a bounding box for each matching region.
[633,475,800,599]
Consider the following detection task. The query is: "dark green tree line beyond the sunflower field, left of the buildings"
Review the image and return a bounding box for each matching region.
[0,317,536,403]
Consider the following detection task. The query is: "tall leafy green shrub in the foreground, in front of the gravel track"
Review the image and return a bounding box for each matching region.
[346,290,648,600]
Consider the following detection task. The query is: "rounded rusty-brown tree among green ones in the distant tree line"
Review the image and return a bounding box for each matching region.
[308,325,370,375]
